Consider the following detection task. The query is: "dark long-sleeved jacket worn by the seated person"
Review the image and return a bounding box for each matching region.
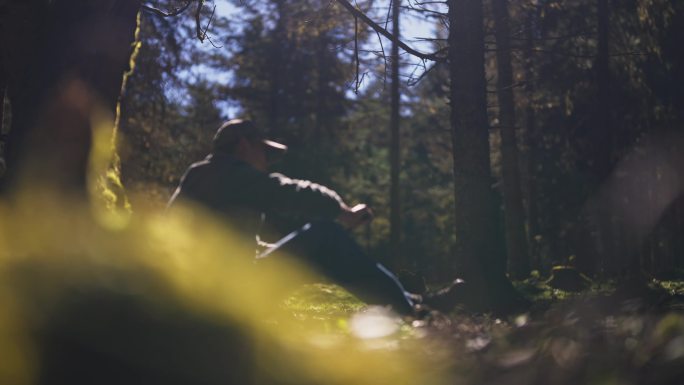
[169,154,342,238]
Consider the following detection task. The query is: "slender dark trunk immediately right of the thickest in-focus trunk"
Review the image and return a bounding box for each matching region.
[492,0,530,278]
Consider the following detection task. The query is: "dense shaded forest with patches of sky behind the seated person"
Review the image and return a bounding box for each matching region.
[120,0,684,282]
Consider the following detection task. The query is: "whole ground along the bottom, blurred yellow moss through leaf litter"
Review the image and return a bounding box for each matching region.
[0,195,684,384]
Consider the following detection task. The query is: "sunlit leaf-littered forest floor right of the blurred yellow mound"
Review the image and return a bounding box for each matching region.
[283,279,684,385]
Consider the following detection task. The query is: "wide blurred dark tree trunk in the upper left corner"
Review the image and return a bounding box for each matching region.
[0,0,140,192]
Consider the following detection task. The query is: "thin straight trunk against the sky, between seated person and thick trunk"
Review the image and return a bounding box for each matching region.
[390,0,404,264]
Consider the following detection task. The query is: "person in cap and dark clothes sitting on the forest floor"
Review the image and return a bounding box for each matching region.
[169,119,462,314]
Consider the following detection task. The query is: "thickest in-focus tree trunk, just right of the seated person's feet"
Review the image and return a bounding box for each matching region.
[447,0,514,307]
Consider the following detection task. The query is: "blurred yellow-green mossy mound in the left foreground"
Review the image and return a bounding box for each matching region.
[0,194,448,384]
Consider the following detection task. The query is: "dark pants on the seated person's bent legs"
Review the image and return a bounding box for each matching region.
[258,221,413,314]
